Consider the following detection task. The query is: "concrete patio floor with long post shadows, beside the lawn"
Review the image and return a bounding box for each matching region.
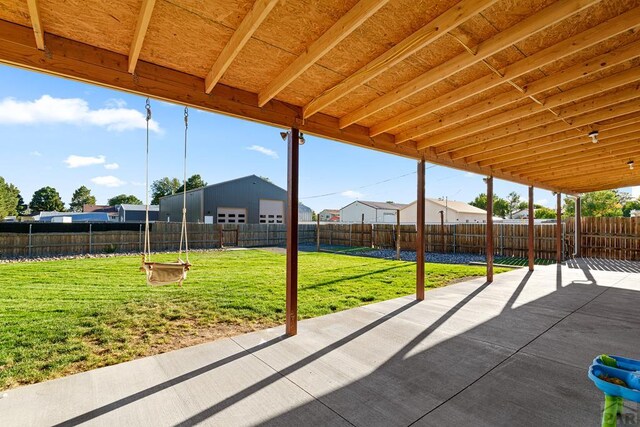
[0,260,640,426]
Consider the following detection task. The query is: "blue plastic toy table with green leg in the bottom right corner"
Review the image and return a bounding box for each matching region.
[589,354,640,427]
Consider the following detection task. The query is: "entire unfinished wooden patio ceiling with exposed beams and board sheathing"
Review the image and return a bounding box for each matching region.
[0,0,640,193]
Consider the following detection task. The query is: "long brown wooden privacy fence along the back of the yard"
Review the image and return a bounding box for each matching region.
[0,218,640,260]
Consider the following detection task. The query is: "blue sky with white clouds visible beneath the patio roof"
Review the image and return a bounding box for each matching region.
[0,65,636,211]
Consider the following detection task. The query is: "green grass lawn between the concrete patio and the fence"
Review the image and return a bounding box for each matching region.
[0,250,501,390]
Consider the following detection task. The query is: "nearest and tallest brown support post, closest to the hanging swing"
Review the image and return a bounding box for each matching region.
[286,128,300,336]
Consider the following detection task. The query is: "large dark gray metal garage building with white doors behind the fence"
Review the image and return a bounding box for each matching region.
[159,175,310,224]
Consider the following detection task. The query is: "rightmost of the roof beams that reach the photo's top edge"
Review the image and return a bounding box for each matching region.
[340,0,598,129]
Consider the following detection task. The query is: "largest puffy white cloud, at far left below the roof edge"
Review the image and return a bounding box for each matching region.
[0,95,160,132]
